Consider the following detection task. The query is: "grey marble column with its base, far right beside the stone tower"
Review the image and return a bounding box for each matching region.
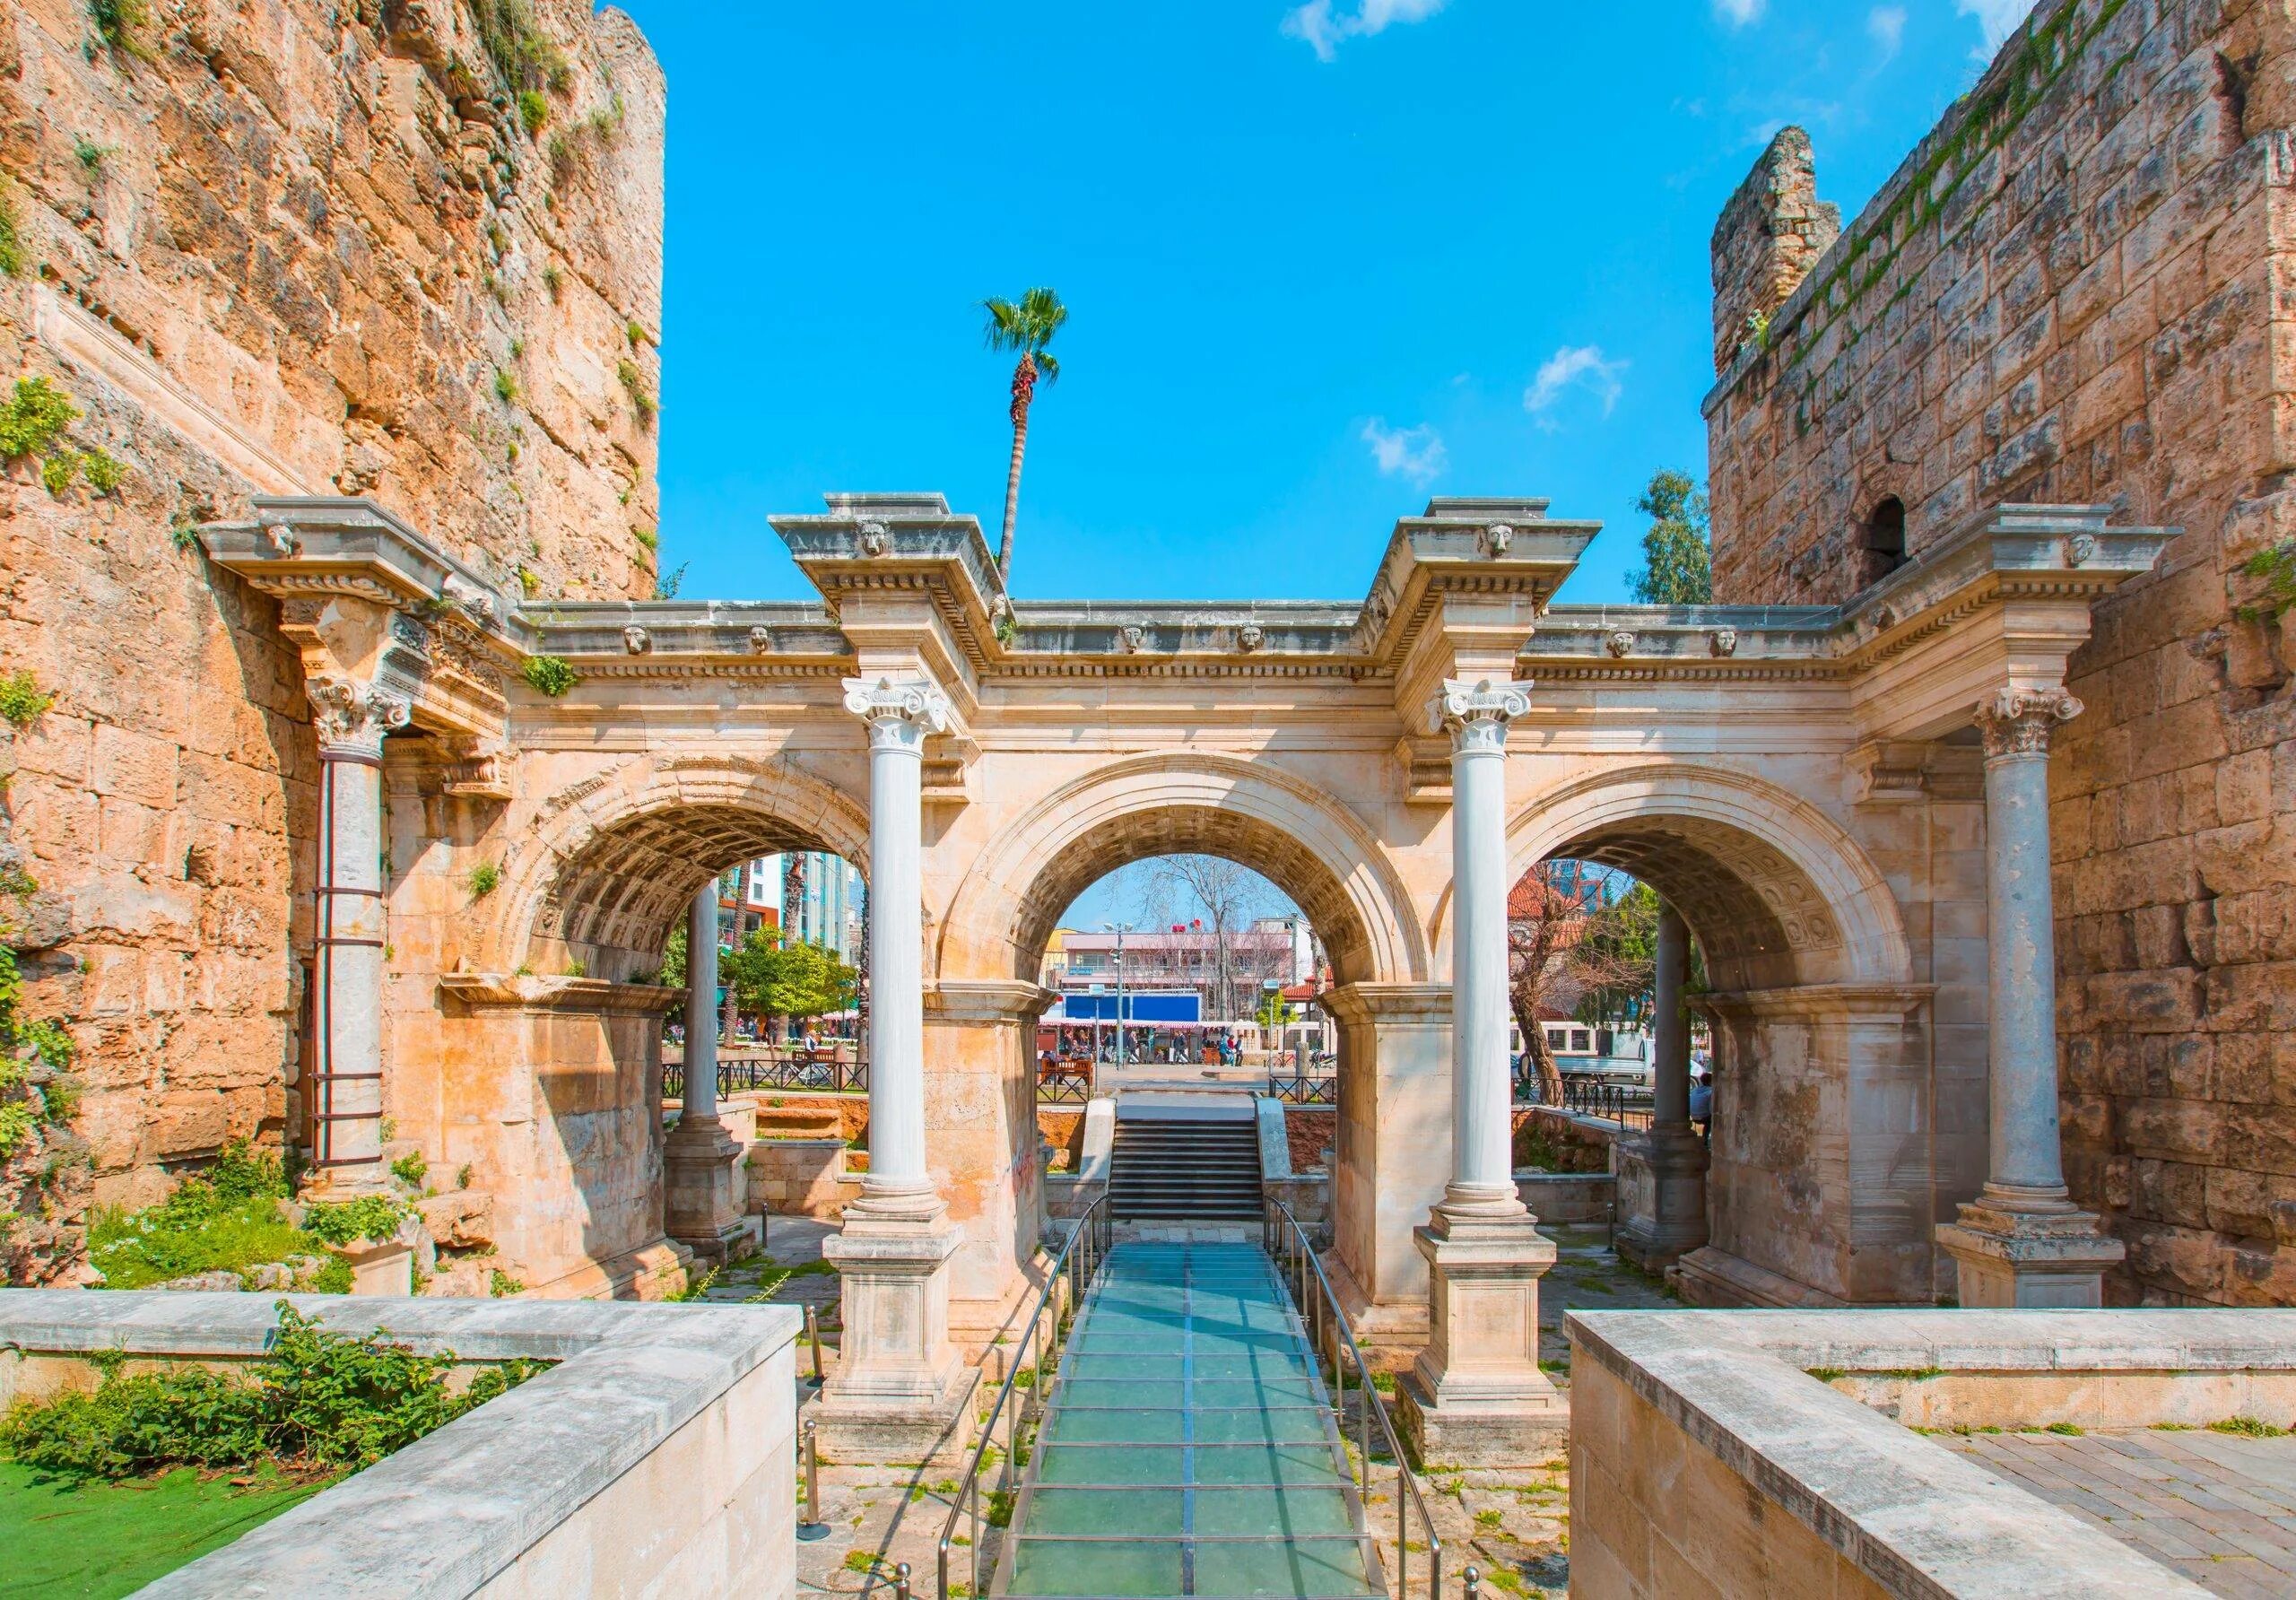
[1938,689,2124,1306]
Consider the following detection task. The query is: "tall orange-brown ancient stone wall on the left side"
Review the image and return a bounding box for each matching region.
[0,0,664,1272]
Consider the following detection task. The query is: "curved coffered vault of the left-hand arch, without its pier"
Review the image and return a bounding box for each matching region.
[473,751,868,978]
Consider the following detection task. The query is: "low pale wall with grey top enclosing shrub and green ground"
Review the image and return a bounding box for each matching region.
[0,1292,799,1600]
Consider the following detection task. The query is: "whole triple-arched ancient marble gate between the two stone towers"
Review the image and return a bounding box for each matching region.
[202,496,2168,1432]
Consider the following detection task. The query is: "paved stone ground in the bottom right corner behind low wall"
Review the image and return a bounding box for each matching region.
[1938,1428,2296,1600]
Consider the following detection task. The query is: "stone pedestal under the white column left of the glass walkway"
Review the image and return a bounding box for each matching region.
[815,1201,971,1465]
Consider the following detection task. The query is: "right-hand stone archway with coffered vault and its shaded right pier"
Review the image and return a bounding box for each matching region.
[1478,764,1943,1304]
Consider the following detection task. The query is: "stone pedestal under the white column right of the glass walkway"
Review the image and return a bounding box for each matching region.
[1396,1207,1570,1467]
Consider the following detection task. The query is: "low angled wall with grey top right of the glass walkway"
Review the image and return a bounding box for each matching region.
[1566,1310,2296,1600]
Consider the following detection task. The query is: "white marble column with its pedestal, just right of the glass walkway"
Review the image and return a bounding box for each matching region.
[1398,680,1568,1467]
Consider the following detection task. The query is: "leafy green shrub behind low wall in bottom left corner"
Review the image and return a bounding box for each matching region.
[0,1300,546,1478]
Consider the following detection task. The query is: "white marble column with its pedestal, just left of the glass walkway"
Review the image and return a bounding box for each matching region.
[820,677,969,1462]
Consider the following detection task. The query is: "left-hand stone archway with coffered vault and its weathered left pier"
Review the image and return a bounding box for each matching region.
[422,753,868,1295]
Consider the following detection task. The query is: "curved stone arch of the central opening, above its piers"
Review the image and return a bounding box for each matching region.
[932,753,1428,982]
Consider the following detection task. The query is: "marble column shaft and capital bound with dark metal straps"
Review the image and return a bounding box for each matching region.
[300,677,411,1194]
